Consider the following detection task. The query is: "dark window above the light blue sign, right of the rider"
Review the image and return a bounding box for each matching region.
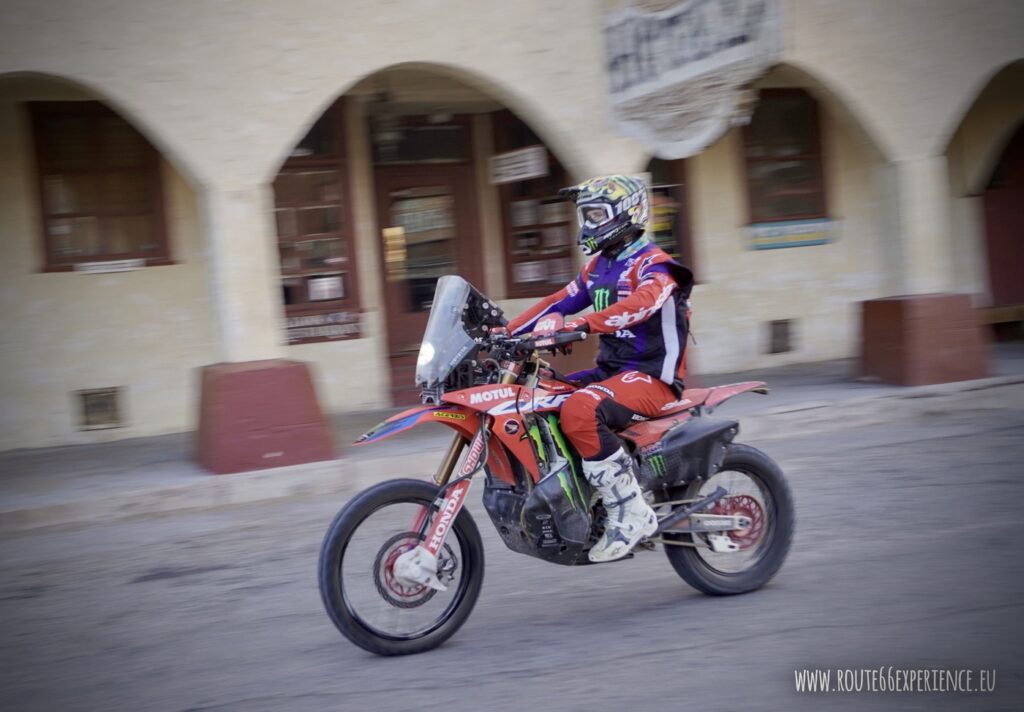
[743,89,827,223]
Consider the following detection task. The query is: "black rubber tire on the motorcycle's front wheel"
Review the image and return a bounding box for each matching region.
[317,479,483,656]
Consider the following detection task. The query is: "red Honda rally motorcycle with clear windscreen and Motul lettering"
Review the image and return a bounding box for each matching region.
[319,276,794,656]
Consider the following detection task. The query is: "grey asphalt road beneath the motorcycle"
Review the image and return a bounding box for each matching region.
[0,399,1024,711]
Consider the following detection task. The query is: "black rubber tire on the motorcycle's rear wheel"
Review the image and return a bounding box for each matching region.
[665,443,796,596]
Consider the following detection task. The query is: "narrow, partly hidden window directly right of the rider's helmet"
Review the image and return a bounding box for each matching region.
[647,158,694,269]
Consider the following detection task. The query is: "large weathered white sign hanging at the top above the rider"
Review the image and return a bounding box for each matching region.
[604,0,779,159]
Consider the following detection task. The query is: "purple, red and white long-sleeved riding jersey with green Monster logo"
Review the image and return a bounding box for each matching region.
[509,238,693,389]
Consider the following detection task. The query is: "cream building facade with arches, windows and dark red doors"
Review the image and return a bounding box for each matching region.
[0,0,1024,449]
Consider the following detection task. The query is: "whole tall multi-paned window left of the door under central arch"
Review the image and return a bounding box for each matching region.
[273,103,359,343]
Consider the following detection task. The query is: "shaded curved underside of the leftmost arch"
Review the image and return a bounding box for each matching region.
[0,71,204,191]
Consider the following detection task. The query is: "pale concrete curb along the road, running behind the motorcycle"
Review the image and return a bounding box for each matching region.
[0,375,1024,534]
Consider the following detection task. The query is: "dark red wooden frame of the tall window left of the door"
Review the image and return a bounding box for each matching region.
[271,99,362,346]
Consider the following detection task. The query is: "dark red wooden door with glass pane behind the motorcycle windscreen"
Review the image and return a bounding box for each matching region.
[376,164,482,406]
